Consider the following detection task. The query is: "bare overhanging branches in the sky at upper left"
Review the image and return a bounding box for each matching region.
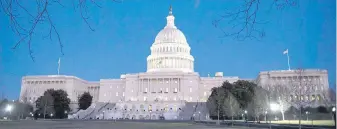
[0,0,122,61]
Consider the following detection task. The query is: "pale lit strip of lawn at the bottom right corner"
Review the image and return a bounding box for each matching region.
[261,120,335,126]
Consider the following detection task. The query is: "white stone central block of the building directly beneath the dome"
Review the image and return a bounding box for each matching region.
[99,72,239,102]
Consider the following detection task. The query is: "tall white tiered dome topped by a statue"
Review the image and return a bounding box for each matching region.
[147,7,194,72]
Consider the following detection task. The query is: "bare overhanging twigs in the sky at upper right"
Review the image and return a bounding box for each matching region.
[213,0,299,40]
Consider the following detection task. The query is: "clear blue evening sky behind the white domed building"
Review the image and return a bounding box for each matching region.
[0,0,336,99]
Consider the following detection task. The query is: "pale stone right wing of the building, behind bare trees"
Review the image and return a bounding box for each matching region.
[256,69,330,107]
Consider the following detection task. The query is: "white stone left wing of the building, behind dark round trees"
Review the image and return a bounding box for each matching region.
[20,75,99,104]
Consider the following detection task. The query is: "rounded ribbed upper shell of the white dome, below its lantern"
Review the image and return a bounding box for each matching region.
[155,27,187,44]
